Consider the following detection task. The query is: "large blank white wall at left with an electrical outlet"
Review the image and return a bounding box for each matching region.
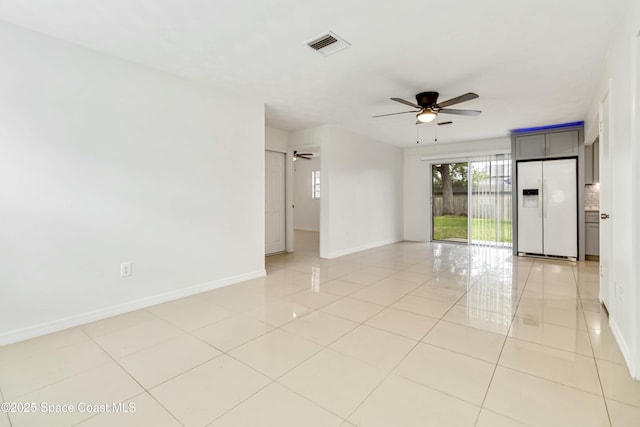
[0,24,265,345]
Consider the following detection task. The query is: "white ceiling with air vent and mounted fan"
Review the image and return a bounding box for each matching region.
[0,0,629,146]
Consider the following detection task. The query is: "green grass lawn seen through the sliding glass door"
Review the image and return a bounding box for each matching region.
[433,215,511,242]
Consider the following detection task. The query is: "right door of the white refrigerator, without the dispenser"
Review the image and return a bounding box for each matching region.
[542,159,578,258]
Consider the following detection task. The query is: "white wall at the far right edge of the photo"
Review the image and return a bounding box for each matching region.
[585,1,640,379]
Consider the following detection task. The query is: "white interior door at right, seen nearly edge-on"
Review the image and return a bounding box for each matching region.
[599,95,613,308]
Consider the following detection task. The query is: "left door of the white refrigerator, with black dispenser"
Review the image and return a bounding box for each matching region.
[517,161,544,254]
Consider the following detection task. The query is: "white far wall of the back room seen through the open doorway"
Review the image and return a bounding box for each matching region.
[293,157,322,231]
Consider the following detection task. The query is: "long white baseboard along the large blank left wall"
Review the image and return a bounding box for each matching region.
[0,270,267,347]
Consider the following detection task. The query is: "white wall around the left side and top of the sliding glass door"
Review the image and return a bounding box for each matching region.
[404,137,511,242]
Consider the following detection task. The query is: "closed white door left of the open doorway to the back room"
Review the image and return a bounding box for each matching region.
[264,151,286,255]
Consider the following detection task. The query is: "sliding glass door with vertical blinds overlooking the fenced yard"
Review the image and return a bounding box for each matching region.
[431,154,512,246]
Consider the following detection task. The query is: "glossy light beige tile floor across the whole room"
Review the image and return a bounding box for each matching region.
[0,232,640,427]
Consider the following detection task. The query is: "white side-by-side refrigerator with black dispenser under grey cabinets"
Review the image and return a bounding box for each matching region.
[517,159,578,258]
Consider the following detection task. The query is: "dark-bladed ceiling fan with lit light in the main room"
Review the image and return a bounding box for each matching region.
[373,92,482,125]
